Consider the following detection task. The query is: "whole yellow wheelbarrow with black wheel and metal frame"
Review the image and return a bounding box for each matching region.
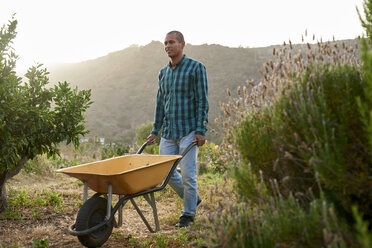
[57,142,196,247]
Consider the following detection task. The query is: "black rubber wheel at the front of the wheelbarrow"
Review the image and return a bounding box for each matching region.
[75,196,114,247]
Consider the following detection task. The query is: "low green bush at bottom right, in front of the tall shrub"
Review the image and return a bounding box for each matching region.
[210,186,348,248]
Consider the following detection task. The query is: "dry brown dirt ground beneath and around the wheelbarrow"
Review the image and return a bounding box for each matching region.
[0,173,218,247]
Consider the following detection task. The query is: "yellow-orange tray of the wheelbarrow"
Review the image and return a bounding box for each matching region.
[57,154,182,195]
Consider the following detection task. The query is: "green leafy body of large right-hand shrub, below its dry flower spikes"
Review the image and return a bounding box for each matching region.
[235,65,372,219]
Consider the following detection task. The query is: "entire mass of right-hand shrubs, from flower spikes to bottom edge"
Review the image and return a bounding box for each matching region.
[203,1,372,247]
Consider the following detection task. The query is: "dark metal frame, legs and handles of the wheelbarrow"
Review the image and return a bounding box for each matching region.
[68,142,197,239]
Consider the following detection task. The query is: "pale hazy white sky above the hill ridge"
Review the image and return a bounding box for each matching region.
[0,0,363,69]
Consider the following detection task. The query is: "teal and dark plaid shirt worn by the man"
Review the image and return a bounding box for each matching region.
[151,55,209,139]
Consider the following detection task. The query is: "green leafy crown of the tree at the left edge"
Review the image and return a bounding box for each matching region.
[0,17,92,211]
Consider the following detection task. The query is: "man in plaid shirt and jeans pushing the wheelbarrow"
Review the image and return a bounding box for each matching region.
[147,31,209,227]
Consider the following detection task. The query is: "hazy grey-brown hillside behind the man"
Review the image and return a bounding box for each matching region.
[49,38,358,143]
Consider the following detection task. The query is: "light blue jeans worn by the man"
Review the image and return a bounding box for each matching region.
[160,131,199,217]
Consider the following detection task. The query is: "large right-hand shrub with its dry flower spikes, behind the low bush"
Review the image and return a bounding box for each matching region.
[215,28,372,220]
